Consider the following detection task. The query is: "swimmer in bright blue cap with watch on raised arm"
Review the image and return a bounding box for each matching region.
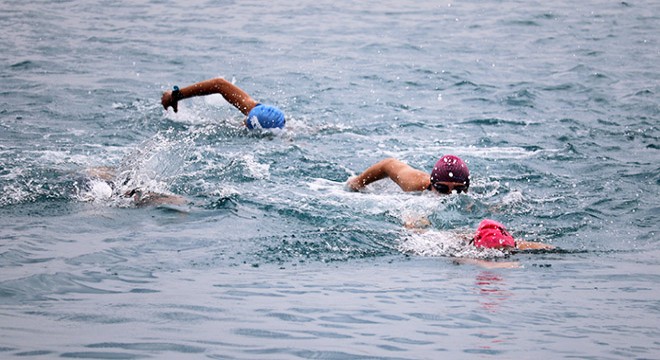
[161,78,286,129]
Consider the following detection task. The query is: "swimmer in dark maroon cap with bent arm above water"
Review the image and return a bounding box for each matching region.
[346,155,470,194]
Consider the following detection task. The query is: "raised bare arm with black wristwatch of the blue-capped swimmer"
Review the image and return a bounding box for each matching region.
[161,78,258,115]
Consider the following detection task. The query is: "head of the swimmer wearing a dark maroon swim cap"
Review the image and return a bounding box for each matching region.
[431,155,470,194]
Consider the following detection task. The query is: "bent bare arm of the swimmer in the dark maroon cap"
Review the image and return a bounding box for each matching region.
[346,158,431,191]
